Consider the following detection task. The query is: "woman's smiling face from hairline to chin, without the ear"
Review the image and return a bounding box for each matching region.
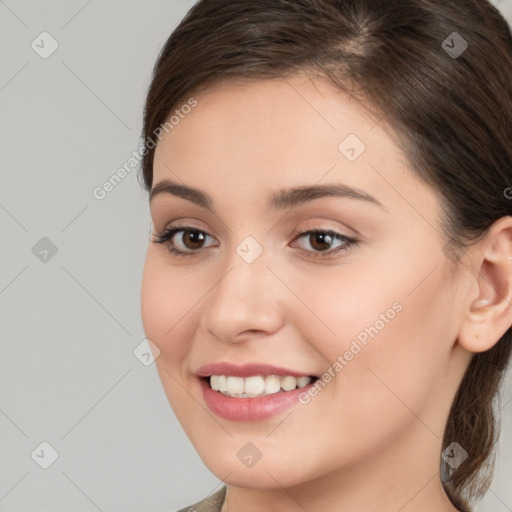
[142,75,467,488]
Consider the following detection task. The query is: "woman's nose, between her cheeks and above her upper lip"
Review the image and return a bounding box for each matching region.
[200,244,285,343]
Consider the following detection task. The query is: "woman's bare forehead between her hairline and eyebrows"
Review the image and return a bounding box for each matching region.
[153,75,438,220]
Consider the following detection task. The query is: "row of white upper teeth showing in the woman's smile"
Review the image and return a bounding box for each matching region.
[210,375,311,398]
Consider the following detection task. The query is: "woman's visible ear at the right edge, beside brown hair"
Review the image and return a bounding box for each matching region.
[458,216,512,352]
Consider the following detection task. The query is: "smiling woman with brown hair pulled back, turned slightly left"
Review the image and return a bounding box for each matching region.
[141,0,512,512]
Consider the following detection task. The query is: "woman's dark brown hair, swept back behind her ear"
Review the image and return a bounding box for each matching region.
[137,0,512,509]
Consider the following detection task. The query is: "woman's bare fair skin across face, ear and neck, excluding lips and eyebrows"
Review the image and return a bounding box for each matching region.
[141,75,512,512]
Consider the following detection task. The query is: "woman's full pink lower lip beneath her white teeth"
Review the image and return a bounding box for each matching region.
[199,378,316,423]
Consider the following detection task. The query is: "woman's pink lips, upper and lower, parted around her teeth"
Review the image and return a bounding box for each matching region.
[196,363,314,422]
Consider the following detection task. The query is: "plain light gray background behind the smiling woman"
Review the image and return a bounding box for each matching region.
[0,0,512,512]
